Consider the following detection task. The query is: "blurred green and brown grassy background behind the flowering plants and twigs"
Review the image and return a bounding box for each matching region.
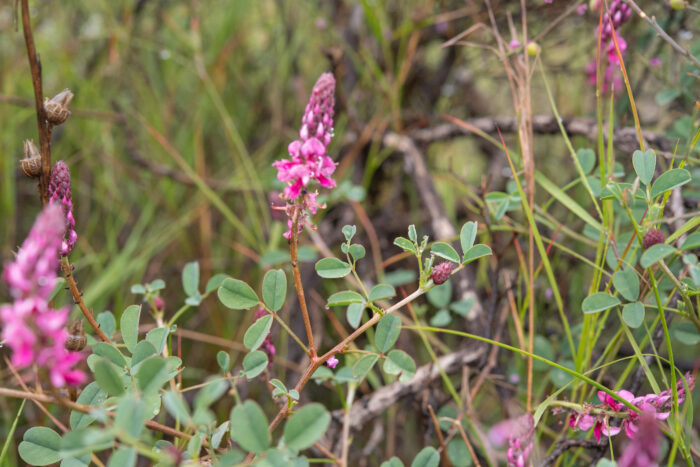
[0,0,700,464]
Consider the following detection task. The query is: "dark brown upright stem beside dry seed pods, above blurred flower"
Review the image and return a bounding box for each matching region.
[22,0,51,206]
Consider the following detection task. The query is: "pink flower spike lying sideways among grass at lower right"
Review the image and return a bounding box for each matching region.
[569,373,695,441]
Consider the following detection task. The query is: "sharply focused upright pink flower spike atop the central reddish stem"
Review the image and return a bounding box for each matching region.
[272,73,337,238]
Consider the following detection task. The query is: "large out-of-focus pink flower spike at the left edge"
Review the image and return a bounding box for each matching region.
[0,204,86,387]
